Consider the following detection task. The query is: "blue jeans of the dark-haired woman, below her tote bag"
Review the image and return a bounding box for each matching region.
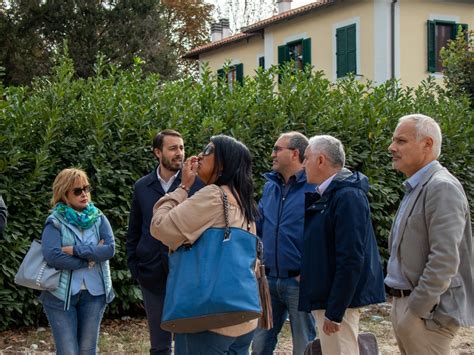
[174,331,255,355]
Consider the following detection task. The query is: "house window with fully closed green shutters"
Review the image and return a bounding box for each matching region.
[336,24,357,78]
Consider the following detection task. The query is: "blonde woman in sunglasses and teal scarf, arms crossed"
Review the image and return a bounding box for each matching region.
[39,168,115,355]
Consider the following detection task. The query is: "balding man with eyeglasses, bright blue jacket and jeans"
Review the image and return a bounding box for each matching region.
[252,132,316,355]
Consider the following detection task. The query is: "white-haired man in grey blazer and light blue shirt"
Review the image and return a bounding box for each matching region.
[385,114,474,354]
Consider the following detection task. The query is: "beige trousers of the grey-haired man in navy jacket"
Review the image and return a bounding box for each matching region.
[312,308,360,355]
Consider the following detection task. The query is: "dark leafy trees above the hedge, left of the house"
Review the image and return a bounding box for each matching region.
[0,0,212,84]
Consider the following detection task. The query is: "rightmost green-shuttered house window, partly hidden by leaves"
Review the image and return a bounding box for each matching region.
[427,20,468,73]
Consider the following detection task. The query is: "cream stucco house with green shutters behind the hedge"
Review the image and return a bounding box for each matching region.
[185,0,474,86]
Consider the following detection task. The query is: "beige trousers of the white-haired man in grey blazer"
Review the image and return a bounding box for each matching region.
[390,297,459,355]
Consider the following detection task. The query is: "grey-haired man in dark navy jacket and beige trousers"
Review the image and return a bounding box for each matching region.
[299,136,385,355]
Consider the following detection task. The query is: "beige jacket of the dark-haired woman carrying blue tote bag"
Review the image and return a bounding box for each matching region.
[150,185,258,337]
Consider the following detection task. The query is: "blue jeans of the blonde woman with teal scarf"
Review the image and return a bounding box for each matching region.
[43,290,106,355]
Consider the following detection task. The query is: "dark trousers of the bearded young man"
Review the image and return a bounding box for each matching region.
[141,287,171,355]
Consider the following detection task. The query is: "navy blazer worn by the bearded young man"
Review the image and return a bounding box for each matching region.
[126,168,204,294]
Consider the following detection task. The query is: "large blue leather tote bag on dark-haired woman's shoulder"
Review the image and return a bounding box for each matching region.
[161,193,262,333]
